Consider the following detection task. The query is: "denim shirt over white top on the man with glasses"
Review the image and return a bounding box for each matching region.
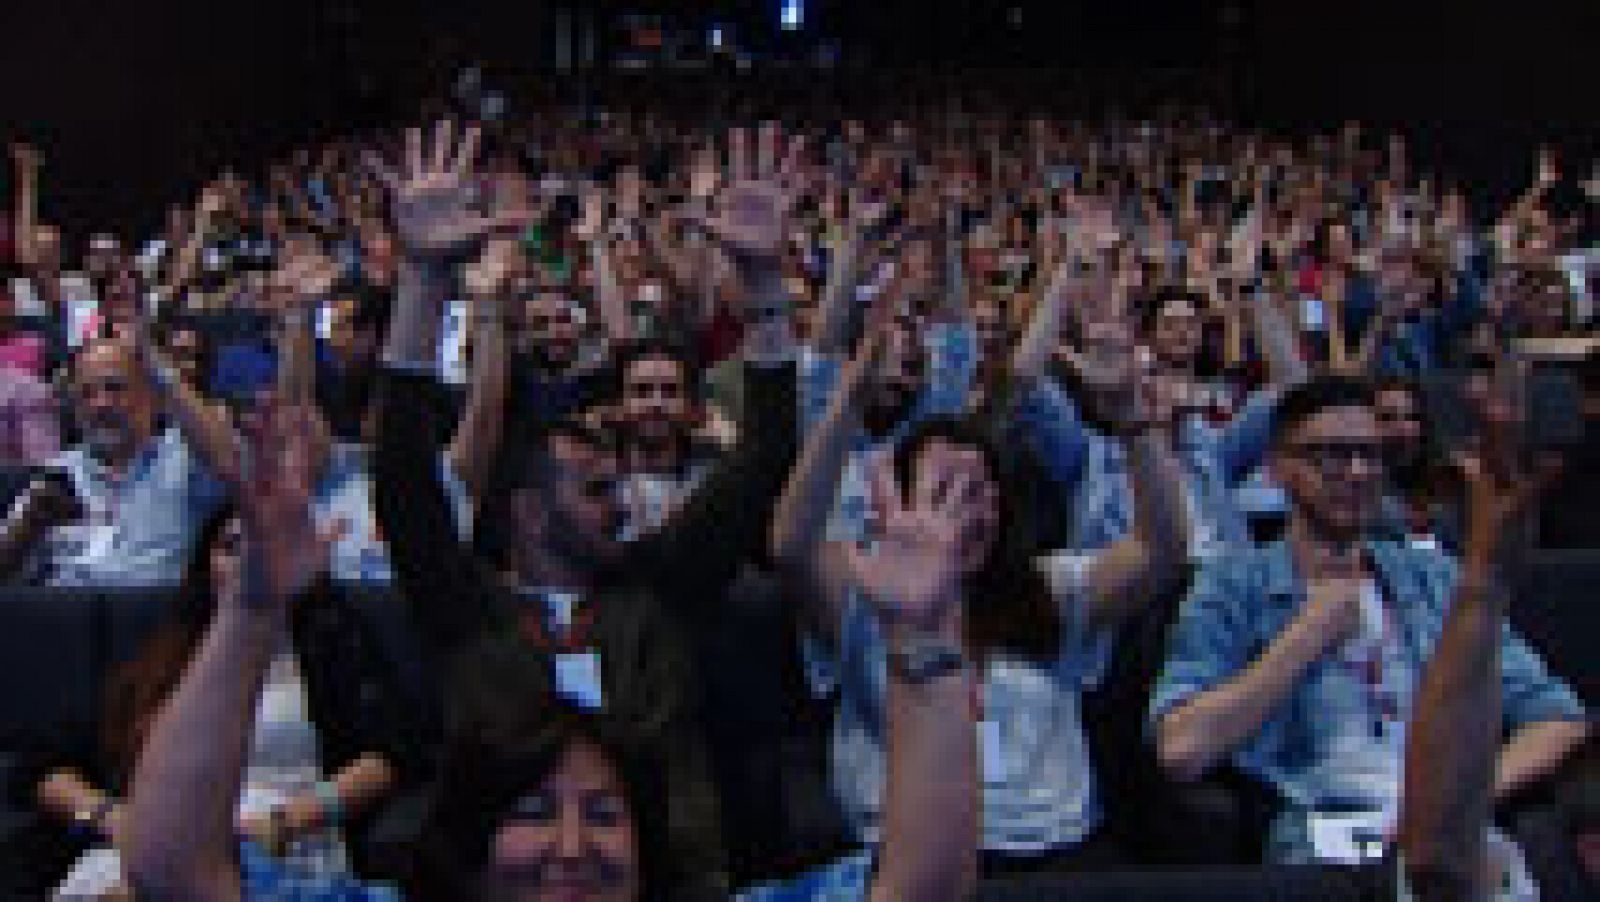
[1149,542,1584,857]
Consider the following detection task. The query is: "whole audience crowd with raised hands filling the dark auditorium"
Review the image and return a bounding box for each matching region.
[0,79,1600,900]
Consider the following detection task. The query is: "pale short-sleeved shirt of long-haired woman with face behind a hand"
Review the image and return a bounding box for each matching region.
[808,555,1110,854]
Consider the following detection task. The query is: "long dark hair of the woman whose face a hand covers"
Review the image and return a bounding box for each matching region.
[894,417,1062,664]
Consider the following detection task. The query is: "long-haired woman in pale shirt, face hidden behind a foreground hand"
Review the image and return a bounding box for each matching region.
[773,327,1186,875]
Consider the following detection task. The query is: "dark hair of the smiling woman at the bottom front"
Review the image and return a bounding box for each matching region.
[406,643,672,899]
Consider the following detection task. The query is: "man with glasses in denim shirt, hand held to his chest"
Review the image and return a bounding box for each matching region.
[1150,377,1586,864]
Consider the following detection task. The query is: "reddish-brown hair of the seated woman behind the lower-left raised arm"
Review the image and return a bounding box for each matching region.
[101,504,235,777]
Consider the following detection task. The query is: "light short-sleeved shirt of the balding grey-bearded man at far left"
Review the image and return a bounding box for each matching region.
[42,429,226,585]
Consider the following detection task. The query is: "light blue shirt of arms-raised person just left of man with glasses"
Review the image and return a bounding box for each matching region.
[1016,379,1278,557]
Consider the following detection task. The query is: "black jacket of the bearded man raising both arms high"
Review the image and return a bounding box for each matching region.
[374,358,797,899]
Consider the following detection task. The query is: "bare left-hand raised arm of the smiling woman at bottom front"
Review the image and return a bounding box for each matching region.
[122,401,326,902]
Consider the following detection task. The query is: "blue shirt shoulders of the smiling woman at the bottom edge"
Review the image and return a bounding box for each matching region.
[240,843,872,902]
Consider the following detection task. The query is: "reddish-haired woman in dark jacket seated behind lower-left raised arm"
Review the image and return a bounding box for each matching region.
[21,486,416,896]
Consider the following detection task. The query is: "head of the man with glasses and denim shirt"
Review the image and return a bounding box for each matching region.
[1269,376,1384,542]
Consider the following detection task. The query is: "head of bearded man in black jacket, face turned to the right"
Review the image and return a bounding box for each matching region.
[496,421,624,577]
